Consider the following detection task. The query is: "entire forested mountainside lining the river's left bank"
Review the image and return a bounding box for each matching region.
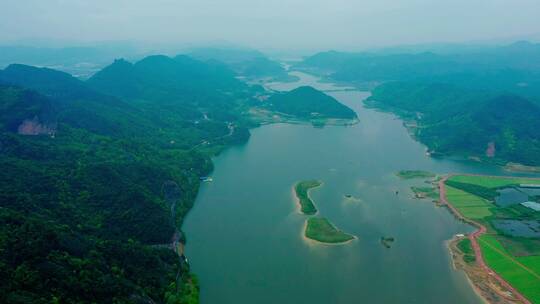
[0,57,251,303]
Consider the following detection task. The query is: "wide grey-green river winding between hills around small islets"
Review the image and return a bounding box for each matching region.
[183,72,528,304]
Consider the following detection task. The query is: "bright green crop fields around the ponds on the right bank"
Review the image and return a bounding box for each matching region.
[446,175,540,303]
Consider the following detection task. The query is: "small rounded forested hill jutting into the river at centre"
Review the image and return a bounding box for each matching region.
[268,86,356,119]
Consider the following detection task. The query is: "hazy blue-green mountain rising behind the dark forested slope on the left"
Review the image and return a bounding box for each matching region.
[86,55,253,143]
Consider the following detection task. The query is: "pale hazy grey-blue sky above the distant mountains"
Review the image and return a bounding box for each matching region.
[0,0,540,48]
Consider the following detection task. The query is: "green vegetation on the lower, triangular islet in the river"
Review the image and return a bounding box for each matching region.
[305,217,355,244]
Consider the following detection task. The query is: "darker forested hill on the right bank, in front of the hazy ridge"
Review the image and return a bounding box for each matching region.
[368,82,540,165]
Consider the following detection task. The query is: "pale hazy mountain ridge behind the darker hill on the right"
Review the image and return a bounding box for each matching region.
[294,42,540,97]
